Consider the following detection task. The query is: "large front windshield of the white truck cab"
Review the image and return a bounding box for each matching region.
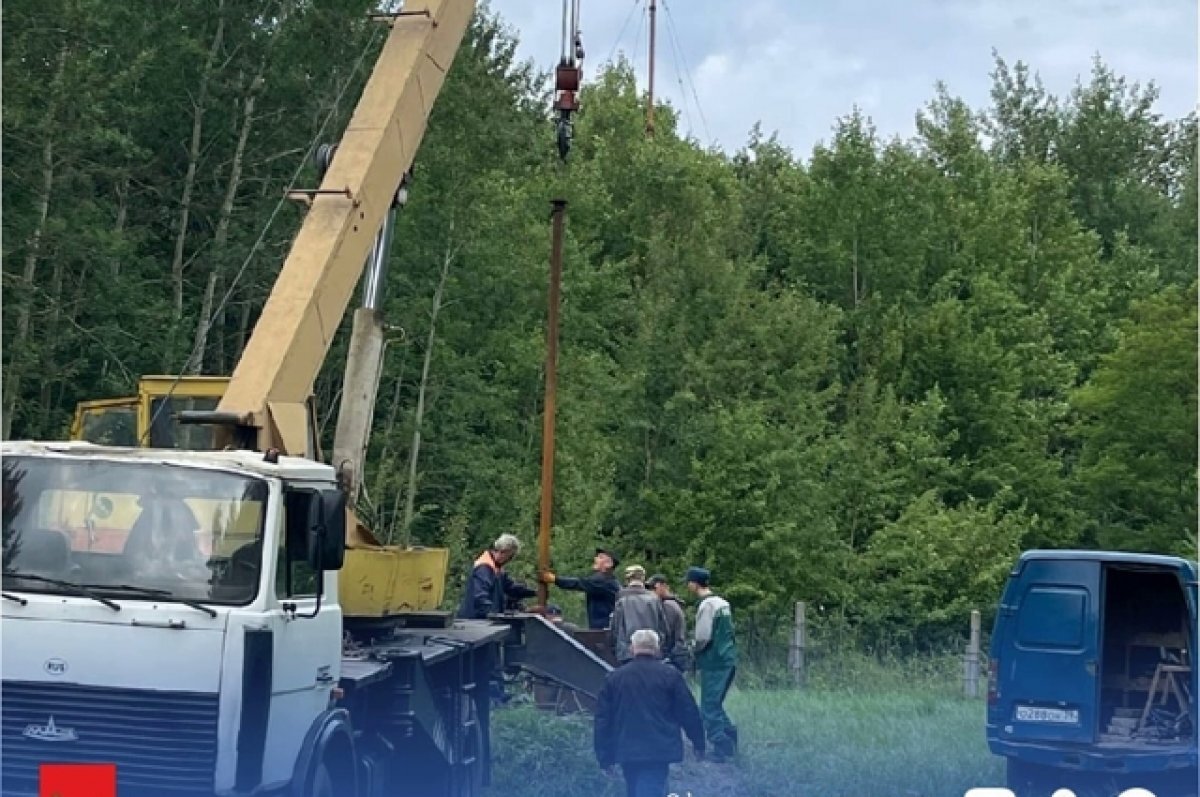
[0,456,268,605]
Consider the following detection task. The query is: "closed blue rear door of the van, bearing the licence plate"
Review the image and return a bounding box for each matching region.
[994,559,1102,743]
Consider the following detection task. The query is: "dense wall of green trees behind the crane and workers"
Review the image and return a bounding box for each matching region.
[2,0,1196,642]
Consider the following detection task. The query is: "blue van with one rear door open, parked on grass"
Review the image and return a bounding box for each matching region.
[988,551,1200,797]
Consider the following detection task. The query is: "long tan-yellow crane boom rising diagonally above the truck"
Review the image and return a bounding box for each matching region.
[217,0,475,456]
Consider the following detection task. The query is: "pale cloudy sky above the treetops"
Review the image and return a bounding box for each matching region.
[486,0,1198,157]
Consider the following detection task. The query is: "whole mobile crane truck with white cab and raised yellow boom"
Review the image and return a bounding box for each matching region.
[0,0,608,797]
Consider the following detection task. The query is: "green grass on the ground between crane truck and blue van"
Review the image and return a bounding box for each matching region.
[490,669,1003,797]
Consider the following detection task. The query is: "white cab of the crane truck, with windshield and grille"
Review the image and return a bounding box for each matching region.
[0,442,346,797]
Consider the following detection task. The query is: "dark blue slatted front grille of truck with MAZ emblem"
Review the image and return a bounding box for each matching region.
[0,681,218,797]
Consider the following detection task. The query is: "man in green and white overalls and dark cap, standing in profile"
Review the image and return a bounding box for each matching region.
[686,568,738,762]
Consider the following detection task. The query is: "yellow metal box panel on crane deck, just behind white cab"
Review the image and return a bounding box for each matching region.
[337,546,450,617]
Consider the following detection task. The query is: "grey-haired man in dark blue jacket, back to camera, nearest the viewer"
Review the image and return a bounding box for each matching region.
[593,629,704,797]
